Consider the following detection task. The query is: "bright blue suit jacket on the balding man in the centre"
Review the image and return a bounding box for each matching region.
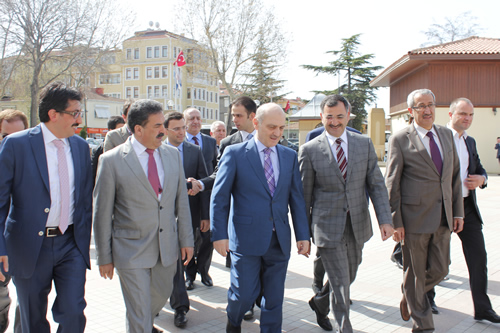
[210,140,309,257]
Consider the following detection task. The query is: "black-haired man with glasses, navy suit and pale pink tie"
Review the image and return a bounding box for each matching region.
[0,82,92,333]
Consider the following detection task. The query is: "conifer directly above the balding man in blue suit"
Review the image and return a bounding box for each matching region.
[242,27,285,104]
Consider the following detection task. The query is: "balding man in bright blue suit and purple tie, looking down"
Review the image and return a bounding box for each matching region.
[210,103,310,333]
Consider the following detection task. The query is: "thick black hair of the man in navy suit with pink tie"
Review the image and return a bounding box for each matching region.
[38,81,83,123]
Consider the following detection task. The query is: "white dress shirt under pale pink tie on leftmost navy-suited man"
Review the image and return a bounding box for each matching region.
[40,123,75,227]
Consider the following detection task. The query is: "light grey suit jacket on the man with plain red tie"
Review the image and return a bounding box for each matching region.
[93,139,194,269]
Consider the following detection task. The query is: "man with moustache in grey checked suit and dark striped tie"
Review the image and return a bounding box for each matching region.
[299,95,393,333]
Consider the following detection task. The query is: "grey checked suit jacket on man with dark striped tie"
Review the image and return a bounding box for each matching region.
[299,132,392,247]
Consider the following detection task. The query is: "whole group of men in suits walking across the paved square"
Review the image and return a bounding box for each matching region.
[0,82,500,333]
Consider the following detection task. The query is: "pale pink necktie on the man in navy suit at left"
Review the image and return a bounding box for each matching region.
[52,140,70,234]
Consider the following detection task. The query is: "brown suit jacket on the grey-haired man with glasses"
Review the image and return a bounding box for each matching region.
[385,125,464,233]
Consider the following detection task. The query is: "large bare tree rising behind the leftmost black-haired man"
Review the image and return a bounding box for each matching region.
[0,0,133,126]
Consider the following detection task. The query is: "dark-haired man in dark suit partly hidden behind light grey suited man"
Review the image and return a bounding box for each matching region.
[165,112,210,328]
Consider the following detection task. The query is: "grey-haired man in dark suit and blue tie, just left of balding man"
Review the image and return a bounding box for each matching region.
[184,108,217,290]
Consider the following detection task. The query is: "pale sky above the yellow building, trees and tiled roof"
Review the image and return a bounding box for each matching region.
[125,0,500,113]
